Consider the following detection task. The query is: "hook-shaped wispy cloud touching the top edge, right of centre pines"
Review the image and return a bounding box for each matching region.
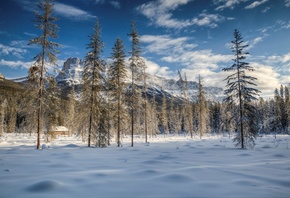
[137,0,224,29]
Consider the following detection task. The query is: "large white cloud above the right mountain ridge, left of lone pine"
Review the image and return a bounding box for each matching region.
[141,35,232,87]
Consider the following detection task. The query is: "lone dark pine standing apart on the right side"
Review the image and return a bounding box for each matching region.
[223,30,259,148]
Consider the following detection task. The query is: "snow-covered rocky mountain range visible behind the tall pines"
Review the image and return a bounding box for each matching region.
[56,58,223,101]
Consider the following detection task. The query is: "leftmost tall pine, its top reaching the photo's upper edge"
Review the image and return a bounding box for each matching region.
[29,0,60,149]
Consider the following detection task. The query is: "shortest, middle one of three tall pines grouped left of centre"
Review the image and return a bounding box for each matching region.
[109,38,127,147]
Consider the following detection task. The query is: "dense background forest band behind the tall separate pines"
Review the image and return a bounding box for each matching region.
[0,76,290,144]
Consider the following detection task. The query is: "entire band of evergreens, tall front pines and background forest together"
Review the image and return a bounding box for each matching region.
[0,0,290,149]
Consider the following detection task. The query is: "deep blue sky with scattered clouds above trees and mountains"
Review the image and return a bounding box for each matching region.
[0,0,290,97]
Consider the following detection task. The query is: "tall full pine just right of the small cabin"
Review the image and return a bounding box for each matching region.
[82,20,104,147]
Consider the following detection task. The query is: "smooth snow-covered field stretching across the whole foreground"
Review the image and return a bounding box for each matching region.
[0,134,290,198]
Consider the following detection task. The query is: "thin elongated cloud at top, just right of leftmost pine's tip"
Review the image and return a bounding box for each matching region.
[54,2,96,21]
